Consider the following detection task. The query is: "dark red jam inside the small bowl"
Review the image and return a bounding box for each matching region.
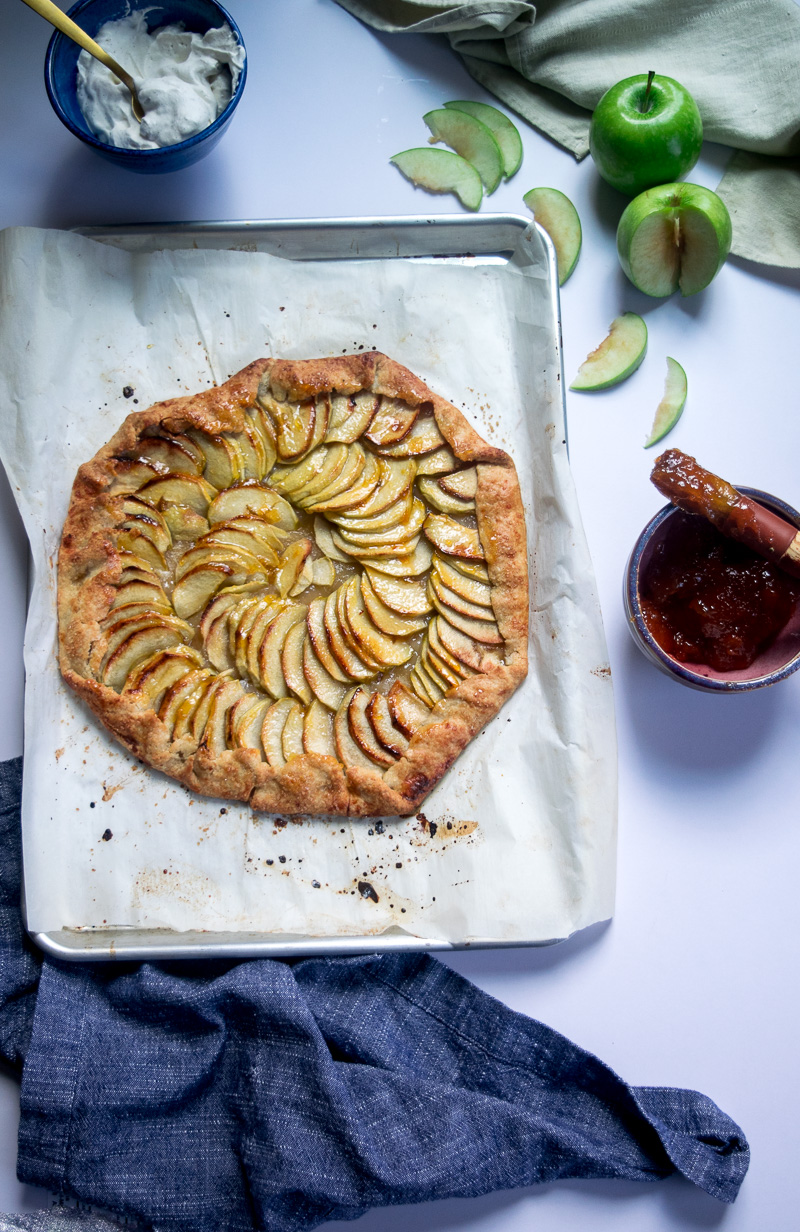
[640,514,800,671]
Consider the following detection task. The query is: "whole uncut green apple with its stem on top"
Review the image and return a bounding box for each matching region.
[589,73,703,197]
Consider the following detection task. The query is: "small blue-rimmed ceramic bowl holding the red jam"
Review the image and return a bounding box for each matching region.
[622,488,800,694]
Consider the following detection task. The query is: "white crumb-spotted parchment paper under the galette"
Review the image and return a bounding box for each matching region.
[0,228,616,942]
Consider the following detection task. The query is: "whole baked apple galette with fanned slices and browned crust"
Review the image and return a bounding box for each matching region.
[58,352,528,816]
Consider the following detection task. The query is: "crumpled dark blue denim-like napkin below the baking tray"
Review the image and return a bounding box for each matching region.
[0,760,749,1232]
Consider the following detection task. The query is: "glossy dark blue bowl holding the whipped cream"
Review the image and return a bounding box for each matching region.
[44,0,242,172]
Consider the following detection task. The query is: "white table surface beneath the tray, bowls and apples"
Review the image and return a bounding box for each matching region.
[0,0,800,1232]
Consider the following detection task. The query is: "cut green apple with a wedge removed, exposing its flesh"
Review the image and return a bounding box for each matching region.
[616,184,731,296]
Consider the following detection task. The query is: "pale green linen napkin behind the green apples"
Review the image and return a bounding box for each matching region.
[338,0,800,269]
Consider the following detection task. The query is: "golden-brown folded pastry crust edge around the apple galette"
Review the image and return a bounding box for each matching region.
[58,352,528,817]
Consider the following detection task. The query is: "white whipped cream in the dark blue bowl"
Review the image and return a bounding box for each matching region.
[78,9,244,150]
